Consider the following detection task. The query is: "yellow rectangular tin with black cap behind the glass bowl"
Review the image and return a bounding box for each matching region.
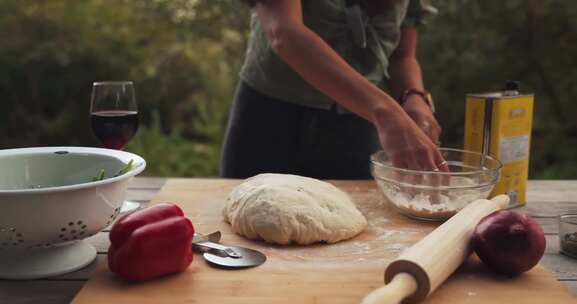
[465,90,533,207]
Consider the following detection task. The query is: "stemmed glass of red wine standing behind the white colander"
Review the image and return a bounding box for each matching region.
[90,81,140,212]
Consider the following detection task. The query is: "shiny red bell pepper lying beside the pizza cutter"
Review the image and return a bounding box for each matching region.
[108,203,194,281]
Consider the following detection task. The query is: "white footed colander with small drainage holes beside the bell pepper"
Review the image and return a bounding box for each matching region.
[0,147,146,279]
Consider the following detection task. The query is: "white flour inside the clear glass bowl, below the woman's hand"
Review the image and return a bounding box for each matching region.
[377,176,492,220]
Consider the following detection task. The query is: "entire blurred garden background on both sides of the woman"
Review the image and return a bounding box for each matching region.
[0,0,577,179]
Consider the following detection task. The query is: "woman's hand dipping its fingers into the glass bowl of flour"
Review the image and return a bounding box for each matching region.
[373,110,449,172]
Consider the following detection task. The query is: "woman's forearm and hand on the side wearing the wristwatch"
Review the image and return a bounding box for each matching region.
[389,27,441,143]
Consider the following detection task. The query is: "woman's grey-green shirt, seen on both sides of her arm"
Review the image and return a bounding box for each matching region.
[240,0,436,109]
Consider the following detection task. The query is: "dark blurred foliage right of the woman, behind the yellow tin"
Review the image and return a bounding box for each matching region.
[419,0,577,179]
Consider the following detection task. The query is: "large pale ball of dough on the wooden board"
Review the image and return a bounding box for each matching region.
[223,173,367,245]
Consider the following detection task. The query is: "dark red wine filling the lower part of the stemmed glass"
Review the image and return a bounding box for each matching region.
[90,110,138,150]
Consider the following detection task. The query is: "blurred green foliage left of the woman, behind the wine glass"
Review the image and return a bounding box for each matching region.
[0,0,249,176]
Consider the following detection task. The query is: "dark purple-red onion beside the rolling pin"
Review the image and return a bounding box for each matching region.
[472,210,545,275]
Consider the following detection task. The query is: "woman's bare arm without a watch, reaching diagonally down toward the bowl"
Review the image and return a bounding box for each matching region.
[257,0,401,122]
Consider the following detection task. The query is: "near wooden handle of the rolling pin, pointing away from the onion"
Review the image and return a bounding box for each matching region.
[361,272,417,304]
